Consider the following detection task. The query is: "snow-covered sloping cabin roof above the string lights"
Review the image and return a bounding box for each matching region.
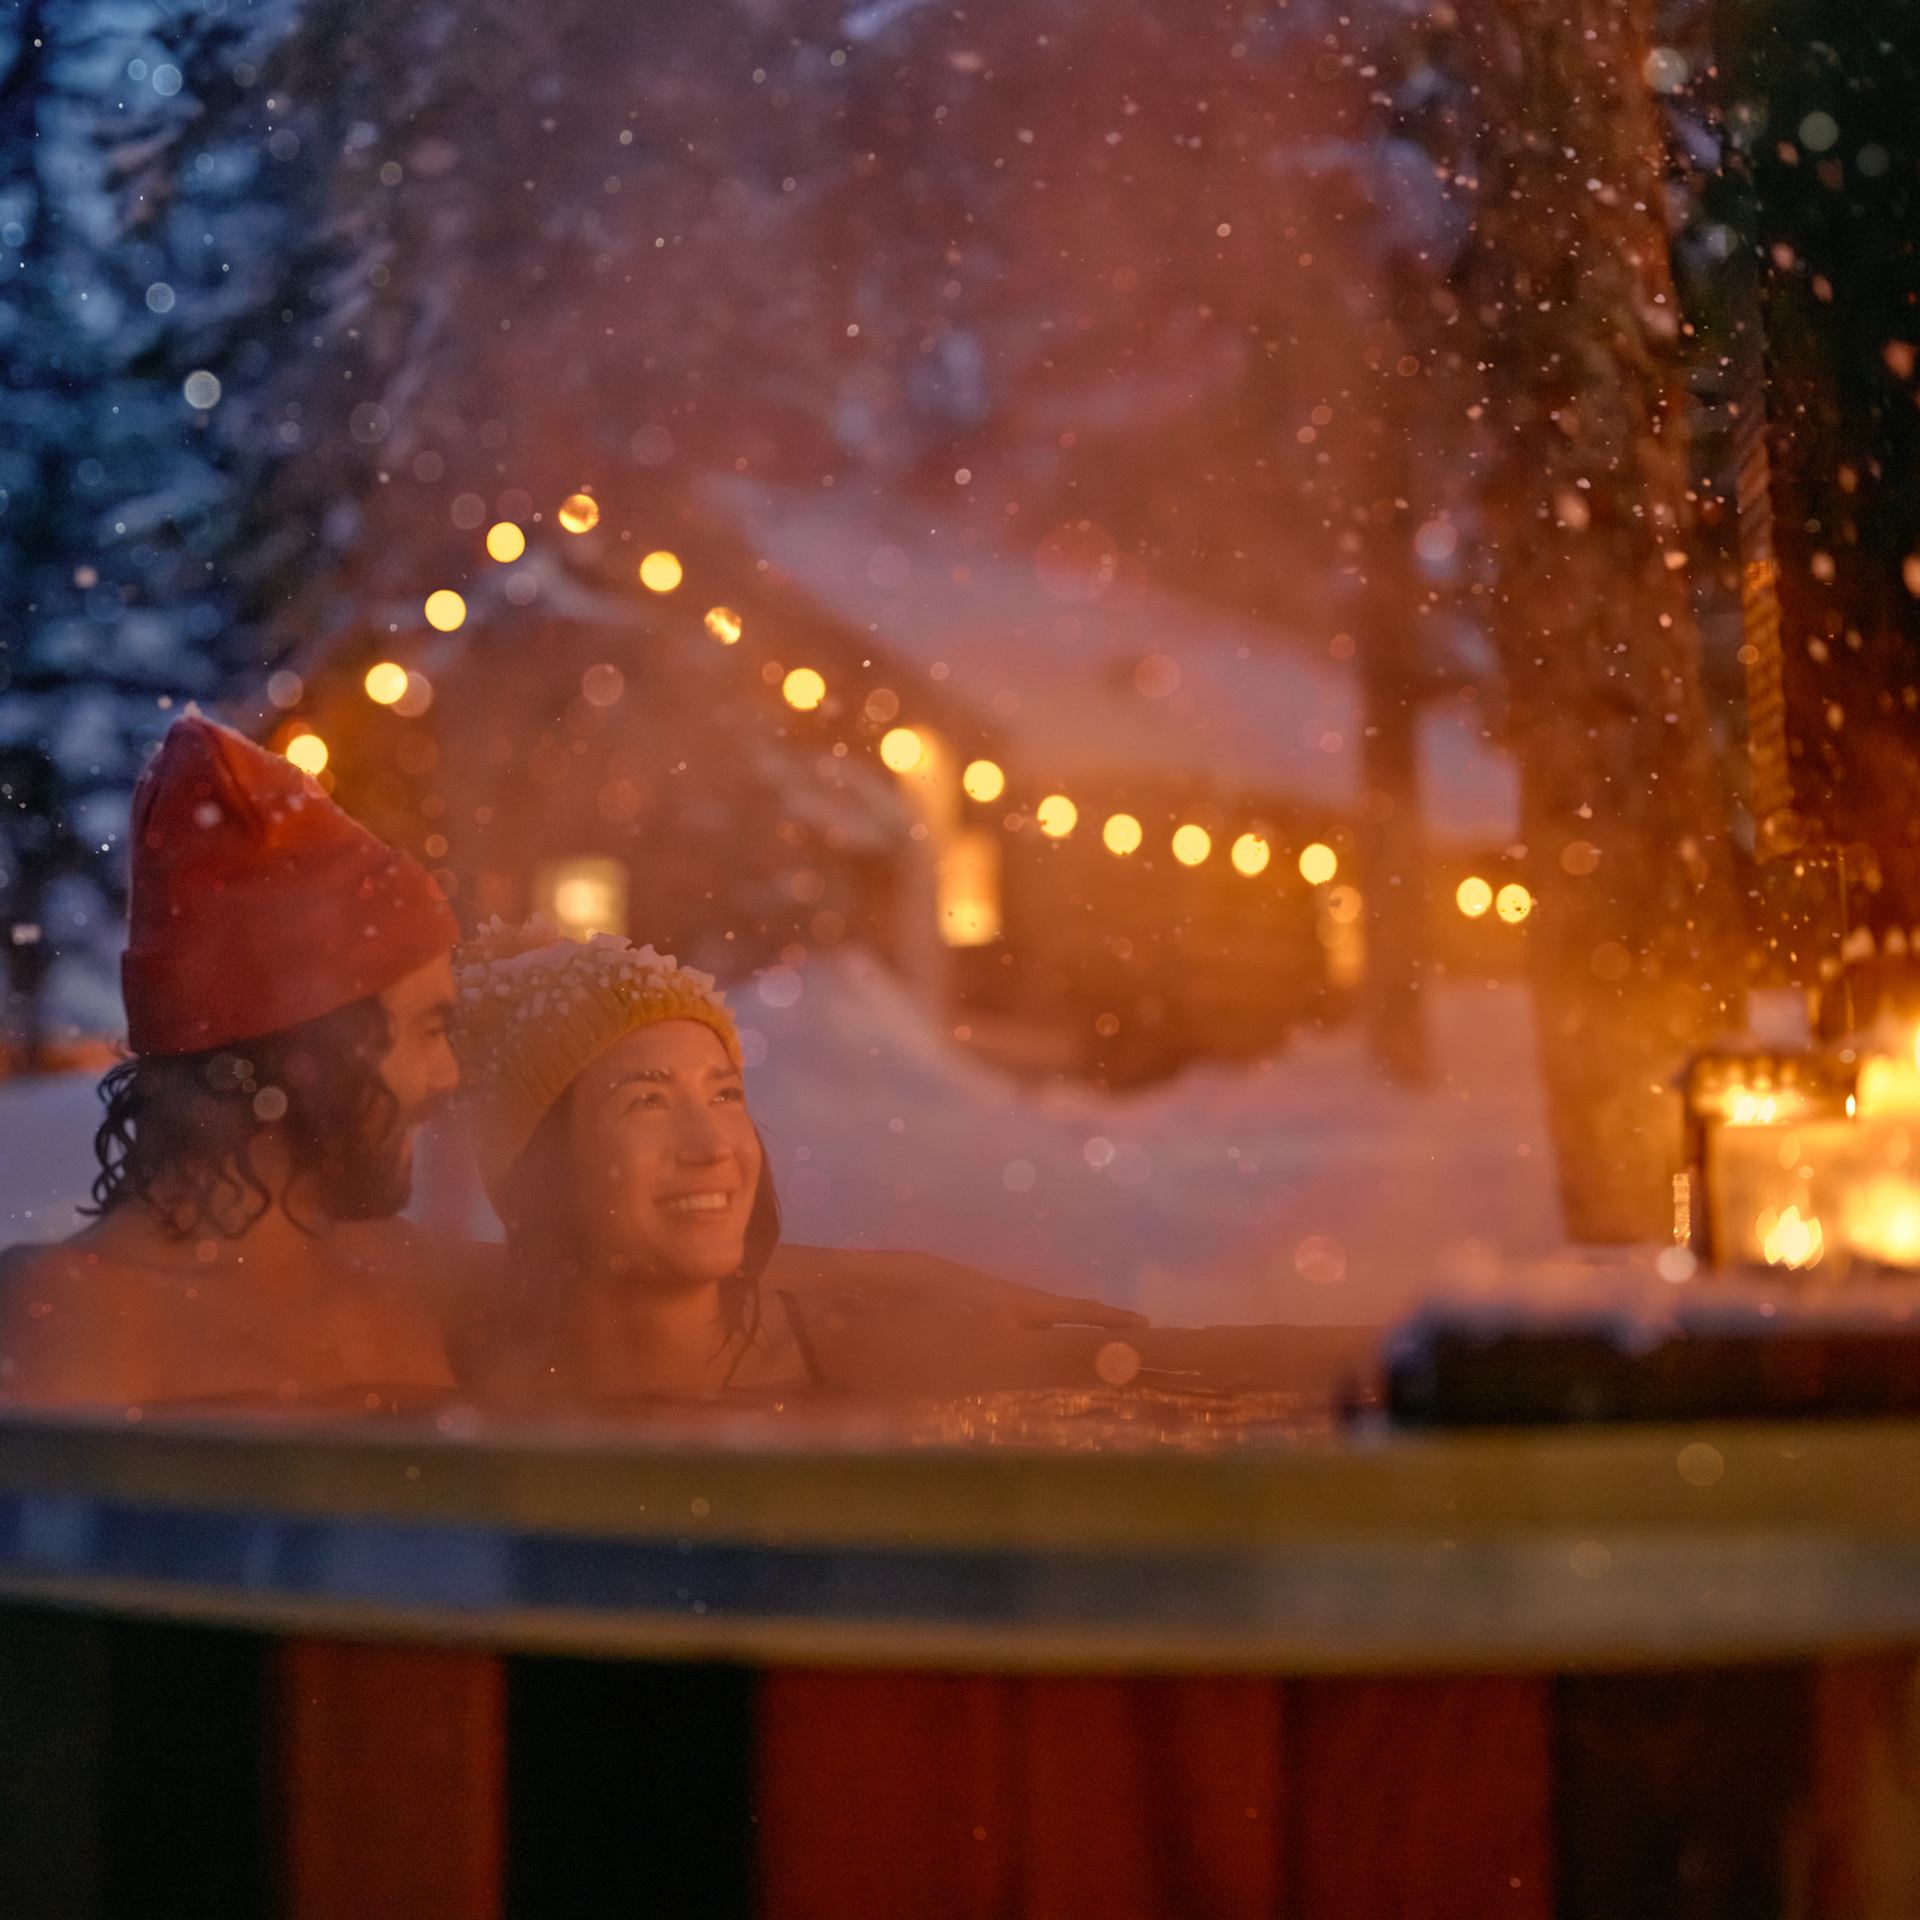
[705,476,1517,841]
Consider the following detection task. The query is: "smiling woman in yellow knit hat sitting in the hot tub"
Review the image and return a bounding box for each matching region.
[453,922,1139,1405]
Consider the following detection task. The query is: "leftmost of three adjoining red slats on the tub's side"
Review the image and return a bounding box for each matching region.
[756,1668,1018,1920]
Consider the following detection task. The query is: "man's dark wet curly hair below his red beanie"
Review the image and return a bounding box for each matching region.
[86,998,407,1238]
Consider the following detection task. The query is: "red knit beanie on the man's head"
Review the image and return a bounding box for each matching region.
[121,714,459,1054]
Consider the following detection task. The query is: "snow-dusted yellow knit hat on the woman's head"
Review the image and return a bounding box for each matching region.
[453,918,741,1198]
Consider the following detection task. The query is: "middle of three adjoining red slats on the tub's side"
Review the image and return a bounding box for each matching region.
[1018,1676,1284,1920]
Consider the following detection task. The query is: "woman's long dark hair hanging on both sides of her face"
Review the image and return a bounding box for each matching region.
[493,1087,780,1377]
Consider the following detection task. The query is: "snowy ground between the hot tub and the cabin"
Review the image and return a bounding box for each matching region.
[0,954,1561,1325]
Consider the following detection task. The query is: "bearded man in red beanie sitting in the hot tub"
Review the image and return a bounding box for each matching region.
[0,714,459,1405]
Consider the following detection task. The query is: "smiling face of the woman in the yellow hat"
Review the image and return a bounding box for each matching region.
[568,1020,762,1284]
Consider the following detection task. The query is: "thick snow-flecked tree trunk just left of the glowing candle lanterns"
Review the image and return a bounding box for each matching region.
[1457,0,1740,1240]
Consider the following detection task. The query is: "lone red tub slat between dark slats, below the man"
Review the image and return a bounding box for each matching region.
[276,1640,505,1920]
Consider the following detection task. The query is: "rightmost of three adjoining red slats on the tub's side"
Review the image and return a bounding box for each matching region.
[1283,1676,1555,1920]
